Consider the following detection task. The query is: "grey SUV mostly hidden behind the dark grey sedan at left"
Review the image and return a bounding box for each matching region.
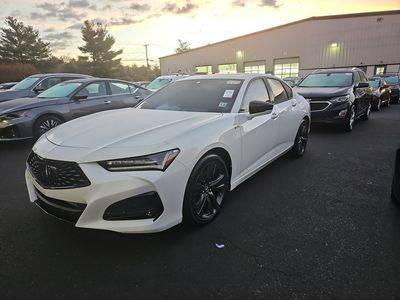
[0,73,91,103]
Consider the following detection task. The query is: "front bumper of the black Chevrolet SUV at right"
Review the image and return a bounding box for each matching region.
[311,102,349,124]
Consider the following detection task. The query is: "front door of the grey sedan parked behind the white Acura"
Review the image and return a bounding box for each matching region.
[69,81,112,118]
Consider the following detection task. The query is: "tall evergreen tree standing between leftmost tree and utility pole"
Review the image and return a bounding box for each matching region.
[79,21,122,76]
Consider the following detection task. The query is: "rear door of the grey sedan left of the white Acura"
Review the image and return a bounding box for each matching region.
[108,80,139,109]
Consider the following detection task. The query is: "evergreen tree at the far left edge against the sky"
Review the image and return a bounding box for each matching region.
[0,17,51,64]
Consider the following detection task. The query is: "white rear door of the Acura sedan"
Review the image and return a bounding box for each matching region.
[267,78,299,144]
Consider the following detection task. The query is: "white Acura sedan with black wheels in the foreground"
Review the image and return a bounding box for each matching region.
[26,74,310,233]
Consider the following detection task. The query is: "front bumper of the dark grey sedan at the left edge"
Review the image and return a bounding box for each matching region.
[0,118,33,142]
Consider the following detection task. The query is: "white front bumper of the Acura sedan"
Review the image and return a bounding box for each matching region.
[25,160,190,233]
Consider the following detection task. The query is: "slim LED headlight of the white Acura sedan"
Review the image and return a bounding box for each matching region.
[99,149,180,172]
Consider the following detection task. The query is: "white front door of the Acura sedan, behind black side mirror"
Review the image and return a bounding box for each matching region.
[239,77,279,173]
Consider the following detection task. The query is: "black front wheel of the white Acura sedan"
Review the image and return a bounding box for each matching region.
[182,154,230,226]
